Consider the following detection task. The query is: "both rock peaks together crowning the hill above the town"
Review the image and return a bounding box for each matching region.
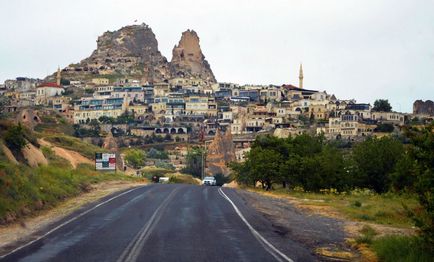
[55,24,215,83]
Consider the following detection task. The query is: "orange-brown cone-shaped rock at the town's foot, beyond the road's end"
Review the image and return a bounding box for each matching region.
[206,130,236,176]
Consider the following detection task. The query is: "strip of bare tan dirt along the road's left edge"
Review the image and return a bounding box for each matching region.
[0,181,143,254]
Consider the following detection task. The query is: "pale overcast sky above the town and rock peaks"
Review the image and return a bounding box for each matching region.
[0,0,434,112]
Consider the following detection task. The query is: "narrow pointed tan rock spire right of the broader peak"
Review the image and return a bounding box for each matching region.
[170,30,216,83]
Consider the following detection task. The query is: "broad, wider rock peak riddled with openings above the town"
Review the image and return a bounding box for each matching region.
[62,24,170,82]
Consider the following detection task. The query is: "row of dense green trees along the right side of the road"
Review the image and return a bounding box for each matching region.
[230,123,434,246]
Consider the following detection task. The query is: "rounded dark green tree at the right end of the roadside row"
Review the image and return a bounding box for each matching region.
[352,137,404,193]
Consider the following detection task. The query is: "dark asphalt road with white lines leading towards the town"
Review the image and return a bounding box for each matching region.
[0,184,318,262]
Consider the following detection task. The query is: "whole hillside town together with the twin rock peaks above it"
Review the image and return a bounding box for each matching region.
[0,24,434,176]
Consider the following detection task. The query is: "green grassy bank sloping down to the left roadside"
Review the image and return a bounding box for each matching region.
[0,161,137,224]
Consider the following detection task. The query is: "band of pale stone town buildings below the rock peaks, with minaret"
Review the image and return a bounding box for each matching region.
[0,61,433,172]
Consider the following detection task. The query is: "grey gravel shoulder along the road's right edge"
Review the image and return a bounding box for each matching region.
[236,189,358,261]
